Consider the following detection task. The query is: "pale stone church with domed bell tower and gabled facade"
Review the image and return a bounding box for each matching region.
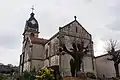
[19,12,96,76]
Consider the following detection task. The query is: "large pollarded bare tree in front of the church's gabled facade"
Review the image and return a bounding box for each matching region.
[62,41,89,76]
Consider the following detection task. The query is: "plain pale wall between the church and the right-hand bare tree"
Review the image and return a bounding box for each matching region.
[96,55,115,78]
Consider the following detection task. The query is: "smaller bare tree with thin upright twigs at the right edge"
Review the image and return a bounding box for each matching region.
[106,39,120,77]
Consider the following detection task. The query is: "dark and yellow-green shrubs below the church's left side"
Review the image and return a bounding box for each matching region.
[20,68,55,80]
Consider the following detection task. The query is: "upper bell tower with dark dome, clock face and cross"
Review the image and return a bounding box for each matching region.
[23,8,39,42]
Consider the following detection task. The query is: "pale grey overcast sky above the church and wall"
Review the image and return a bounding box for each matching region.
[0,0,120,65]
